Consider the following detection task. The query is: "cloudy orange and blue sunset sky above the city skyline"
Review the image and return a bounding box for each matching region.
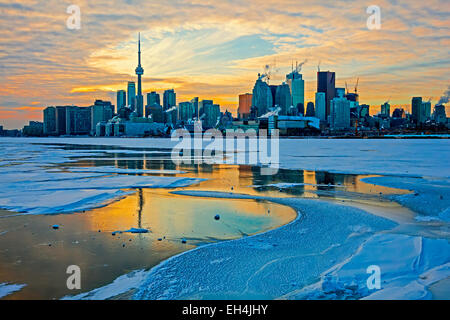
[0,0,450,128]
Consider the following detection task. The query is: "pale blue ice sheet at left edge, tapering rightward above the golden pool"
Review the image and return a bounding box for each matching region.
[0,139,202,214]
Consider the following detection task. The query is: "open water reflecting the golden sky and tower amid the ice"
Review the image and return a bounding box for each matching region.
[0,145,410,299]
